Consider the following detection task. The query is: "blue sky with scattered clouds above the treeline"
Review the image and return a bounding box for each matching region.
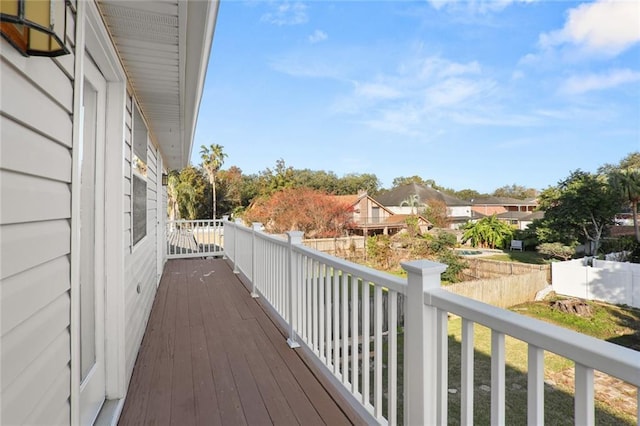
[192,0,640,192]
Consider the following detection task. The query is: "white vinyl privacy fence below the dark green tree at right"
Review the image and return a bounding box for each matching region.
[551,259,640,308]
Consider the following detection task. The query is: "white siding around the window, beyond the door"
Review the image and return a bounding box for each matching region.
[123,101,157,378]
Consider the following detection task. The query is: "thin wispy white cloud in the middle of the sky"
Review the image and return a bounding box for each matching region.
[334,56,496,136]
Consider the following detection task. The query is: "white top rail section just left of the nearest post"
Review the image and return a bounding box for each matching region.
[293,241,407,294]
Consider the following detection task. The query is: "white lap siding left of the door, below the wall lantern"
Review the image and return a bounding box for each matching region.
[0,2,75,425]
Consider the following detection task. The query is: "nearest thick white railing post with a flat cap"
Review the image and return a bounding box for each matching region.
[401,260,447,425]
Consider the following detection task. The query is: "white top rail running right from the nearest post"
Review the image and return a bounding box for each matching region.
[424,288,640,387]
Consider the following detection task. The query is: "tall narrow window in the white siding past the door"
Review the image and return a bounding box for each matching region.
[131,107,147,246]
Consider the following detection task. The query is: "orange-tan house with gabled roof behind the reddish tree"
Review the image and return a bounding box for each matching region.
[332,191,431,236]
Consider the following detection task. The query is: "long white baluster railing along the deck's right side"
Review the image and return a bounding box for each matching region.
[225,222,640,425]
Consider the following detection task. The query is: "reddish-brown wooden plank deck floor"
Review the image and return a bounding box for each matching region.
[119,259,362,425]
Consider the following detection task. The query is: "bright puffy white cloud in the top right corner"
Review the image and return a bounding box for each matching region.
[539,0,640,56]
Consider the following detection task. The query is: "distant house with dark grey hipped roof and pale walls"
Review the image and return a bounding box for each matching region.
[376,183,472,229]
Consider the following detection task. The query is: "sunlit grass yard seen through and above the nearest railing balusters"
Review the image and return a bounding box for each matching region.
[383,301,640,425]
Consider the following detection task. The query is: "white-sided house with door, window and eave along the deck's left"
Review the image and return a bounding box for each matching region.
[0,0,218,425]
